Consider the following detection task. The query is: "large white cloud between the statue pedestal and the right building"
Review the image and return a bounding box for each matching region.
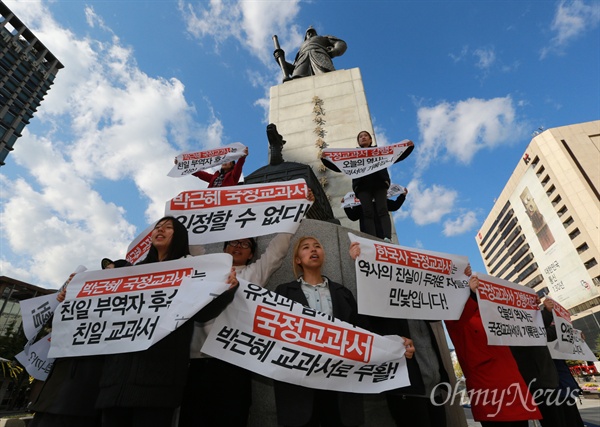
[416,96,524,174]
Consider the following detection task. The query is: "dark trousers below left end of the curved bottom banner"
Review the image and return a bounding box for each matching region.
[179,358,252,427]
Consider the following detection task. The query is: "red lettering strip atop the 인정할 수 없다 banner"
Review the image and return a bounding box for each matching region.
[169,182,307,211]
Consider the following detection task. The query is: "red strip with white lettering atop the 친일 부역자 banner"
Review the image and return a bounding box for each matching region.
[76,267,194,298]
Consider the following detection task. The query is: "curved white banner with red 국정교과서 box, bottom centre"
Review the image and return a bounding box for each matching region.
[202,282,410,393]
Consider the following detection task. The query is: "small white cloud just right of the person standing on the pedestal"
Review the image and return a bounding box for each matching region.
[403,179,457,225]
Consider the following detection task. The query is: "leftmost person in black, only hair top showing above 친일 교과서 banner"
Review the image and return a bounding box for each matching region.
[29,258,131,427]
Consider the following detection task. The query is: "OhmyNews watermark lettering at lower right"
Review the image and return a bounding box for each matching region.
[429,379,580,418]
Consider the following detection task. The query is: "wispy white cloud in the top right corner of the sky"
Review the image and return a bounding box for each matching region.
[540,0,600,59]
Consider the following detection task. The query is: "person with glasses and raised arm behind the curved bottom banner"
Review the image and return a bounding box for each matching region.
[179,190,314,427]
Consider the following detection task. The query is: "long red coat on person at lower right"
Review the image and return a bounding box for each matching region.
[445,298,542,421]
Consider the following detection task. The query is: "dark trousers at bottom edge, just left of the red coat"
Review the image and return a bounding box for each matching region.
[386,393,446,427]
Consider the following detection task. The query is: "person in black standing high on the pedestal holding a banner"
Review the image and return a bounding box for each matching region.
[352,130,392,242]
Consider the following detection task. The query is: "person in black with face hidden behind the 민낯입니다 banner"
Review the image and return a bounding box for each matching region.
[350,242,450,427]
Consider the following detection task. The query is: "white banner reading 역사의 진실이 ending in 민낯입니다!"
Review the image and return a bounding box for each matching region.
[348,233,470,320]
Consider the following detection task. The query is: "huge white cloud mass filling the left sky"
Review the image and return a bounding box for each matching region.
[0,2,223,287]
